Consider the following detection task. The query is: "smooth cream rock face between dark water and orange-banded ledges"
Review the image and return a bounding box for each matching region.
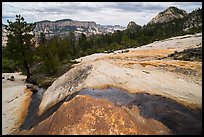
[84,60,202,107]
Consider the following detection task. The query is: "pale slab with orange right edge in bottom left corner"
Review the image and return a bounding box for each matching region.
[2,85,32,135]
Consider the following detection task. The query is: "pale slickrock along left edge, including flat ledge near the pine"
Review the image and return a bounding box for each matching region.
[2,73,32,135]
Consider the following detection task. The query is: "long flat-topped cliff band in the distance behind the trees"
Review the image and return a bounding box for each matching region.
[34,19,126,39]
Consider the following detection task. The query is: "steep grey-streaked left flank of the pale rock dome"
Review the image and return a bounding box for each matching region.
[38,64,91,115]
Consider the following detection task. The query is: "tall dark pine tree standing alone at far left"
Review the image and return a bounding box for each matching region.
[6,15,35,80]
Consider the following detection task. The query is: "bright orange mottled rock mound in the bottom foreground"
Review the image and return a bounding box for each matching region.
[29,95,171,134]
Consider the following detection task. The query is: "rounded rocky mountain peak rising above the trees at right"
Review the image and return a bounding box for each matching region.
[148,6,188,24]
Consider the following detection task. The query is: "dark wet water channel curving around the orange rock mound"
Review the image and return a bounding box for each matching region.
[20,88,202,135]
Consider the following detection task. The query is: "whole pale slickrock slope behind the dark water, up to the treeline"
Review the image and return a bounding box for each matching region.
[39,34,202,115]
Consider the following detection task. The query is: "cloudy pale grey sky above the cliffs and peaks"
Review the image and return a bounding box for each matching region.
[2,2,202,27]
